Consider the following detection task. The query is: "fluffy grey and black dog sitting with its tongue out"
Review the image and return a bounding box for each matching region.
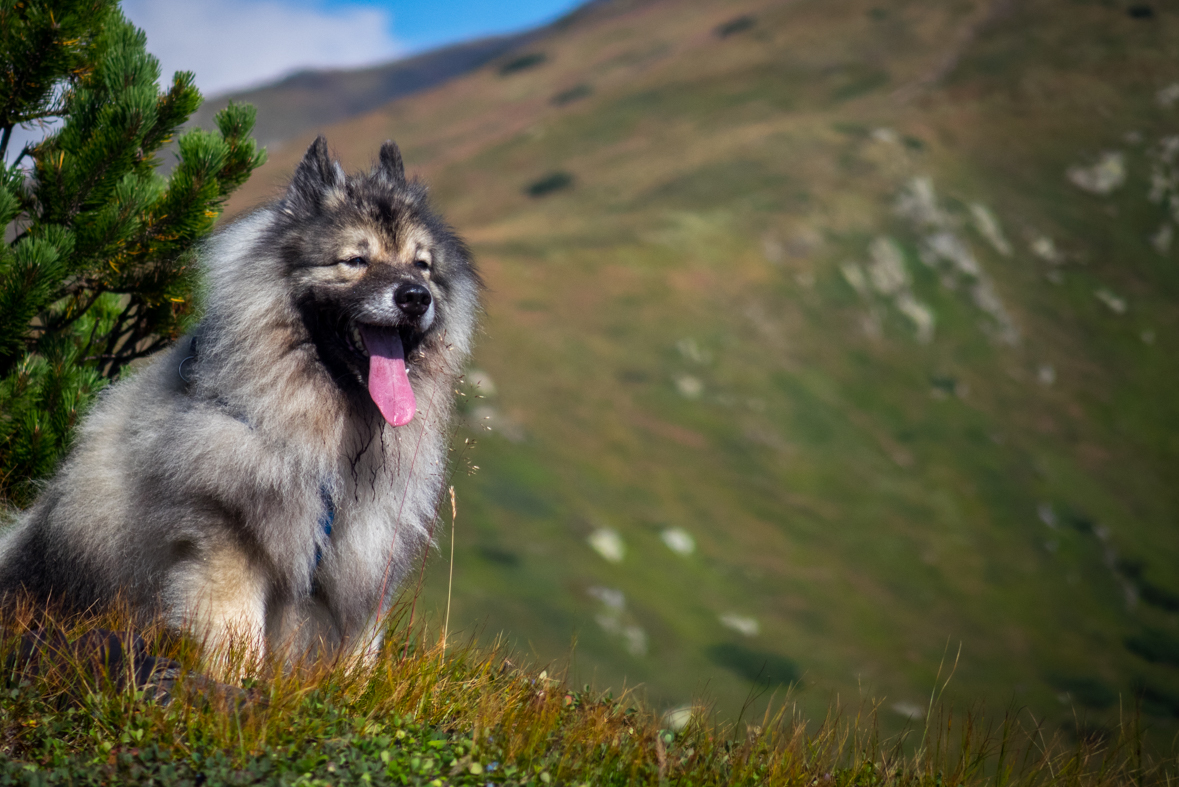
[0,137,482,669]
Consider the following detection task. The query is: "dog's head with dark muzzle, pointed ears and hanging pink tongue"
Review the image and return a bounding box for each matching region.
[272,137,480,426]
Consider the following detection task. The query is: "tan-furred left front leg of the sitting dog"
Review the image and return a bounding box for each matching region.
[169,543,269,683]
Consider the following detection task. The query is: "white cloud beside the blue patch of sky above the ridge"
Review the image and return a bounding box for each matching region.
[123,0,403,95]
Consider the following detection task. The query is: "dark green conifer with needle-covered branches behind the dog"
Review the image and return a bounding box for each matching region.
[0,0,264,504]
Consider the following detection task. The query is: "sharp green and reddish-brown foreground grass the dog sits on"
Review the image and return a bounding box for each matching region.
[0,606,1179,787]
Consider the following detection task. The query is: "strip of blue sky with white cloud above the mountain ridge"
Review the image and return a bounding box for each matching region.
[123,0,581,95]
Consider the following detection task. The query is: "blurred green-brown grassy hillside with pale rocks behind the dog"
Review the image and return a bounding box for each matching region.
[225,0,1179,738]
